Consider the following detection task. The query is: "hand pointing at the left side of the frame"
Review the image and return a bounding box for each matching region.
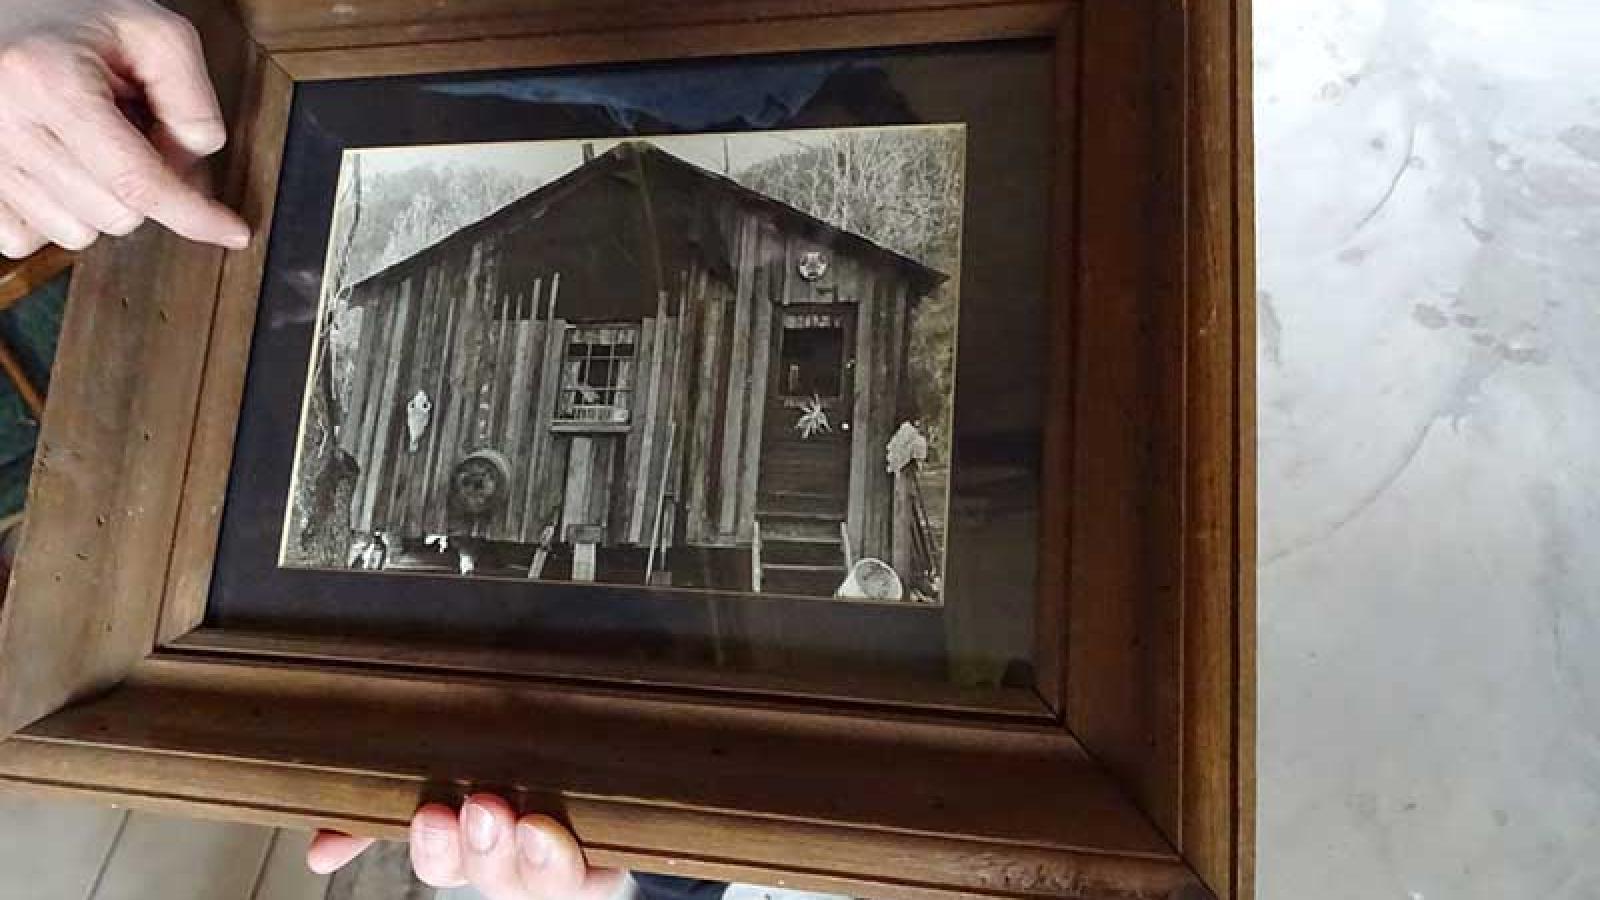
[0,0,250,259]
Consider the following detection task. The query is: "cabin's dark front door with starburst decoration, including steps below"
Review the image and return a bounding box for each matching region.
[757,304,856,596]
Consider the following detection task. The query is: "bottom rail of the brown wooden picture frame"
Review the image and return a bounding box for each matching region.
[0,650,1189,897]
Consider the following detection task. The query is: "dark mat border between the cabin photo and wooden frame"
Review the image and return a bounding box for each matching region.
[208,43,1053,682]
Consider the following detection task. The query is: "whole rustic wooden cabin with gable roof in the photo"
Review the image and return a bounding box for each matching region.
[341,143,944,596]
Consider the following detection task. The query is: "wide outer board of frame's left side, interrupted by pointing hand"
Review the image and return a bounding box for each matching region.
[0,5,254,737]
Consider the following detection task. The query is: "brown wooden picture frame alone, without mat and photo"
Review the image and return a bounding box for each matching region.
[0,0,1254,900]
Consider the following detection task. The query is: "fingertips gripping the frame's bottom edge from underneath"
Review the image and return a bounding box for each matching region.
[306,794,627,900]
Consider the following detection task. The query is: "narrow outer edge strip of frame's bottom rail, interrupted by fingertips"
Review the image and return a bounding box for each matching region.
[0,740,1206,900]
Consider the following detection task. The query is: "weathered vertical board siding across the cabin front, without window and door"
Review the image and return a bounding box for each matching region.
[341,160,910,556]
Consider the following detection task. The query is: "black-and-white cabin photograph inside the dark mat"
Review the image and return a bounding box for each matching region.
[278,125,966,605]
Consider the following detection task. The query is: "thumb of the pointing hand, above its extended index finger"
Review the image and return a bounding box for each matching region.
[114,3,227,157]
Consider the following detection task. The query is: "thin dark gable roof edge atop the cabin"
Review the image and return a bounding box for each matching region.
[354,139,949,296]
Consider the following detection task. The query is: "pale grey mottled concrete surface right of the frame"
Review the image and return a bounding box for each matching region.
[1256,0,1600,900]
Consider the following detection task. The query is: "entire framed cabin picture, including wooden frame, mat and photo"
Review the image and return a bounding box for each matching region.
[0,0,1253,898]
